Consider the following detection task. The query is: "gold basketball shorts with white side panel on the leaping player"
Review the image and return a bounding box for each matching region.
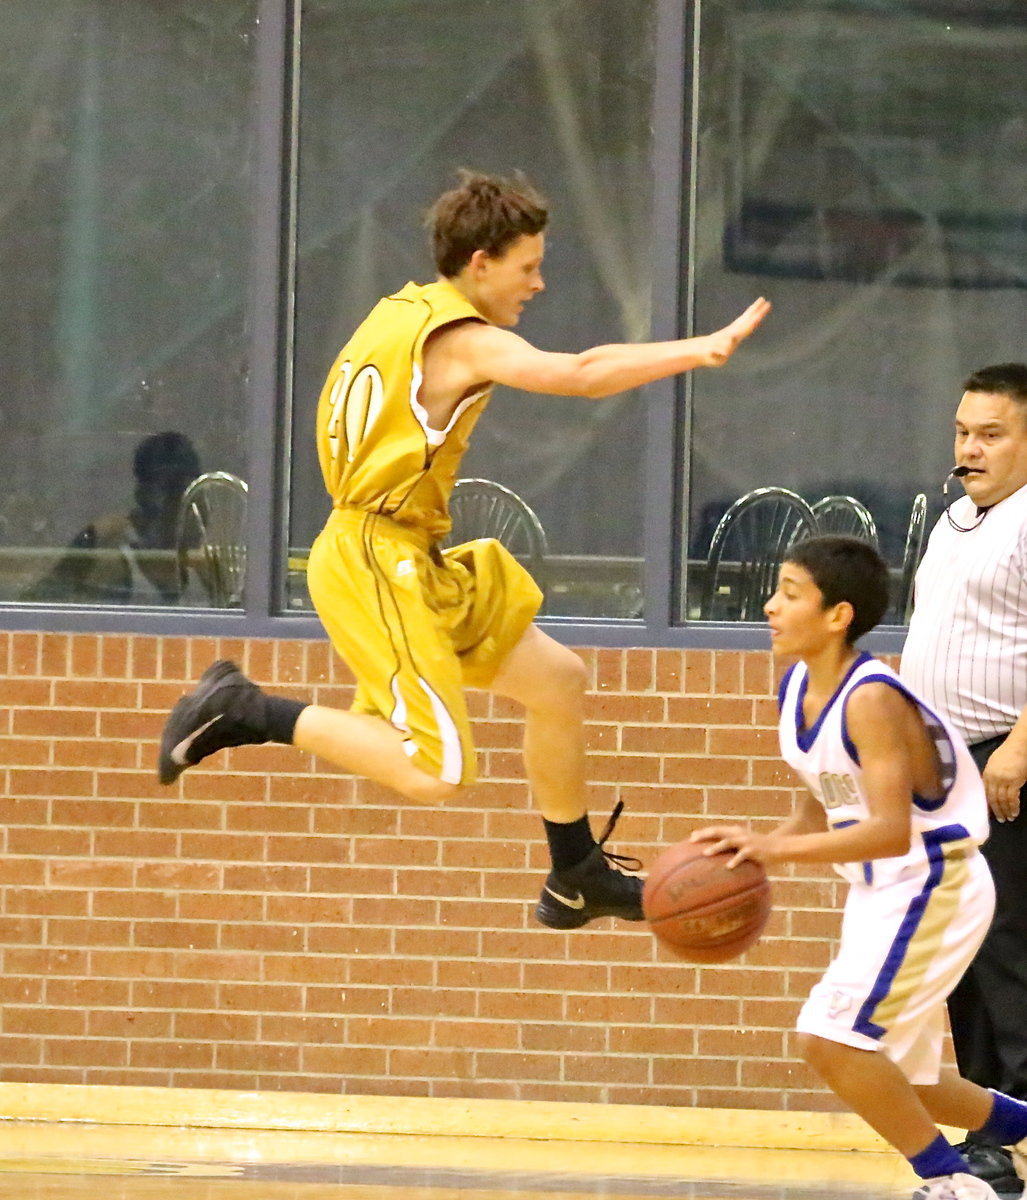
[307,509,542,784]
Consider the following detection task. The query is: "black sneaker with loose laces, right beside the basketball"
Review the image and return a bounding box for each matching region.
[535,800,644,929]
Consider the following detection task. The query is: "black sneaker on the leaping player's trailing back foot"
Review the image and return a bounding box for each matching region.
[157,659,268,784]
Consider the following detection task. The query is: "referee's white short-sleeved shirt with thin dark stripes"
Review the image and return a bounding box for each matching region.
[899,477,1027,745]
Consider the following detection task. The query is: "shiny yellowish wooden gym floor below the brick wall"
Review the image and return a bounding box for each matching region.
[0,1085,914,1200]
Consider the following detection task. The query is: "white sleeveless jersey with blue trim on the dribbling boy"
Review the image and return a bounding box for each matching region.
[779,654,987,887]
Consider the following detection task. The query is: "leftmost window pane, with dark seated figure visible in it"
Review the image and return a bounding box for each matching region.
[0,0,257,607]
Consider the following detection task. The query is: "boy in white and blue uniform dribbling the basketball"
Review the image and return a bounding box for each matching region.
[692,538,1027,1200]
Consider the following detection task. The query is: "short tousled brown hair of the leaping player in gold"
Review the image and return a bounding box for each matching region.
[425,170,549,278]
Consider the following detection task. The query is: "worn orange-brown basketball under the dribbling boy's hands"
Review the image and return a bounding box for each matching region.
[642,841,770,962]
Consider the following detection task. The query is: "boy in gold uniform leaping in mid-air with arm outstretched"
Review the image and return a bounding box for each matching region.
[158,173,770,929]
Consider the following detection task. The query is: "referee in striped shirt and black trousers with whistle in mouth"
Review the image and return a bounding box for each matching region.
[900,362,1027,1200]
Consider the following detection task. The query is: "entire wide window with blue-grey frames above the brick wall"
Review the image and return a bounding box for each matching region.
[0,0,1027,648]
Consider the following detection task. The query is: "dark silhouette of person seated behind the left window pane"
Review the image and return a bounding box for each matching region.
[23,432,200,605]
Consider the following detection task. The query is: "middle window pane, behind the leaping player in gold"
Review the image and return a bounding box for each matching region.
[286,0,655,617]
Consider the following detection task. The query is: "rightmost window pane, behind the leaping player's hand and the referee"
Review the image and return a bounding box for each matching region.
[681,0,1027,622]
